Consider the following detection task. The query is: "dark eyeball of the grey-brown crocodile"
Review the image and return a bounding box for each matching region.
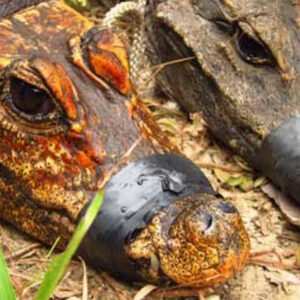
[235,30,273,65]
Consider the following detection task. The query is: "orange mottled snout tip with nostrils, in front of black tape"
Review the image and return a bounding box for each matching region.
[127,195,249,287]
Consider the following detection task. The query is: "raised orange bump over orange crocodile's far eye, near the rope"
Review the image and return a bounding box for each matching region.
[81,27,130,94]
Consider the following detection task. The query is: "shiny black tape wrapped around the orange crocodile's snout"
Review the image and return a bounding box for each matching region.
[79,154,215,280]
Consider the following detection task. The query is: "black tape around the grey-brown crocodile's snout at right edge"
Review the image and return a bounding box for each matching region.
[257,117,300,204]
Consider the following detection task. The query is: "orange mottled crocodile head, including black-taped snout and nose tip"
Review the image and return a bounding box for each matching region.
[0,0,249,286]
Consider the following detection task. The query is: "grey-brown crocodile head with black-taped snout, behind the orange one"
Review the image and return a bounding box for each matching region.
[147,0,300,211]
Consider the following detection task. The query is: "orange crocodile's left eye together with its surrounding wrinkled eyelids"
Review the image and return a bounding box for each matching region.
[2,58,75,135]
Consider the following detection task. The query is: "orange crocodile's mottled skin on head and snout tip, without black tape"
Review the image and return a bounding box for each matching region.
[0,0,249,286]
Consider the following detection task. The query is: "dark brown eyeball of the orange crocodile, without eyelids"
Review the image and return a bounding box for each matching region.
[9,78,55,116]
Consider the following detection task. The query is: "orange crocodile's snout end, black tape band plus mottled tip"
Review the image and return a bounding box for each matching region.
[79,154,249,287]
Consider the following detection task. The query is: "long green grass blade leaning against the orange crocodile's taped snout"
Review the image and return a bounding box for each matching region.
[35,192,103,300]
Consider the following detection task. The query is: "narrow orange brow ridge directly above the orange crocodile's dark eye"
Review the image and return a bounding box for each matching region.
[32,59,77,120]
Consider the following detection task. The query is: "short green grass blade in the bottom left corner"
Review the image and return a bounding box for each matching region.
[0,246,17,300]
